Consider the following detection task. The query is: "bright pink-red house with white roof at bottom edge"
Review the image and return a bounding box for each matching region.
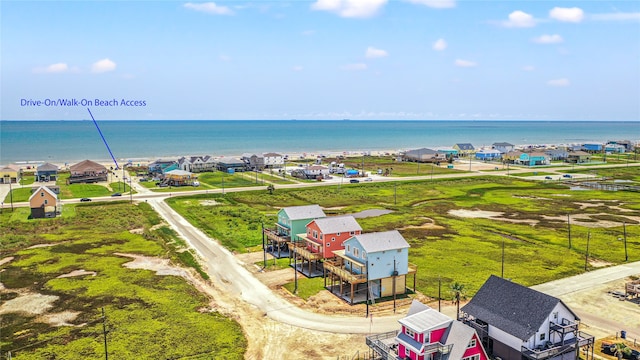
[367,300,489,360]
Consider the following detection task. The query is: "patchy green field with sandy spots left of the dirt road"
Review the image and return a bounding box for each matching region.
[0,203,246,360]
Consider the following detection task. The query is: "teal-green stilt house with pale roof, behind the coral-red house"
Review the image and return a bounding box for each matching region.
[262,205,326,258]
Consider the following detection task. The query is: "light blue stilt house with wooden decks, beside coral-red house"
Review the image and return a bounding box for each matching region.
[324,230,416,304]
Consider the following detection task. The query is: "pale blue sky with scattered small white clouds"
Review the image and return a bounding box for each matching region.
[0,0,640,120]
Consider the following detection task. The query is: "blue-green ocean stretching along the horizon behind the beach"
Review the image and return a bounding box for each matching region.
[0,120,640,165]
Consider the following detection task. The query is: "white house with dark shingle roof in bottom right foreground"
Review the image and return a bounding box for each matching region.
[459,275,594,360]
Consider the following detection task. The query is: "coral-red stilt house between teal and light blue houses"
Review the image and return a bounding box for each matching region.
[294,215,362,277]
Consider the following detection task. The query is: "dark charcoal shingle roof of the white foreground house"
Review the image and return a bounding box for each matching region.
[460,275,579,341]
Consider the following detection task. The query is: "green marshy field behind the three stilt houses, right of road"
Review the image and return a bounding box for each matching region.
[168,178,640,296]
